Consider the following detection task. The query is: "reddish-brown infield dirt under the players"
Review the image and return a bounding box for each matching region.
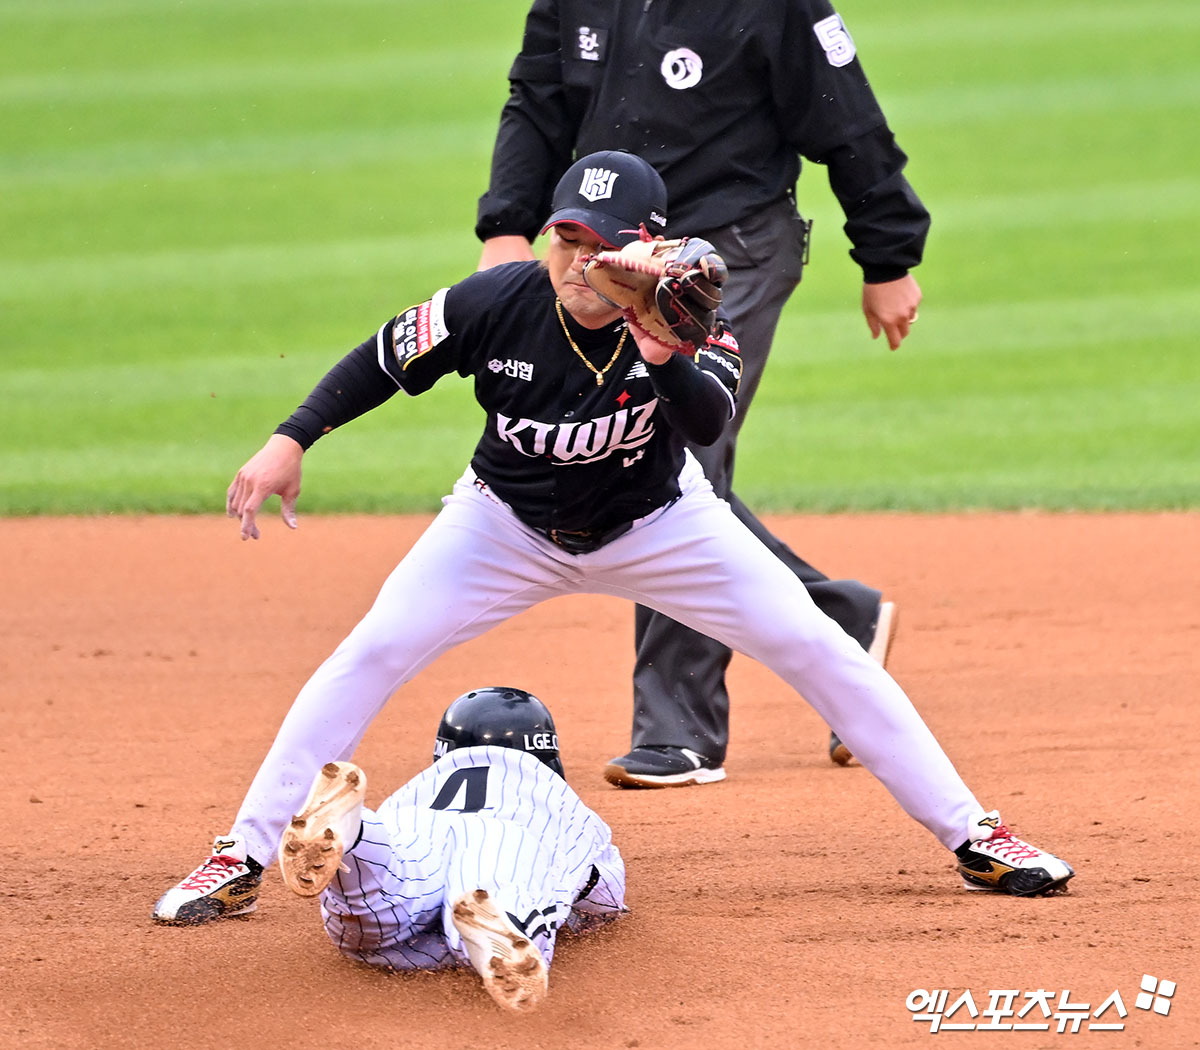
[0,514,1200,1050]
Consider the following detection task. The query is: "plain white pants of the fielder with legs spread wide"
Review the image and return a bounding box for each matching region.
[233,455,982,864]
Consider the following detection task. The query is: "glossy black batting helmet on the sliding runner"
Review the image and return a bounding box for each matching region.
[433,685,565,779]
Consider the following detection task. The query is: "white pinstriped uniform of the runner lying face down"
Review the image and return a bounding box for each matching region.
[322,746,625,970]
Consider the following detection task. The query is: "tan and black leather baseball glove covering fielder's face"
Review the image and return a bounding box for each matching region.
[583,238,728,354]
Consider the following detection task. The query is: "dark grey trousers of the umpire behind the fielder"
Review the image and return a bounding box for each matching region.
[632,198,880,762]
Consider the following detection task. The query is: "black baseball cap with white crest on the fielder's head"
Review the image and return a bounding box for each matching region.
[541,150,667,248]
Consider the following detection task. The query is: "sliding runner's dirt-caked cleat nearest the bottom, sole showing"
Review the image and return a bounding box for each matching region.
[452,889,550,1012]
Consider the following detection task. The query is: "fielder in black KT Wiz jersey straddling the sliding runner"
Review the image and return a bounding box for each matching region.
[154,152,1072,924]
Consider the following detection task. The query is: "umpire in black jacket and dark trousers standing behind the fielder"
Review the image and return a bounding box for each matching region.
[475,0,929,787]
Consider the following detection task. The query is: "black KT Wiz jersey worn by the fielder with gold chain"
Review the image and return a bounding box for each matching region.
[377,263,742,532]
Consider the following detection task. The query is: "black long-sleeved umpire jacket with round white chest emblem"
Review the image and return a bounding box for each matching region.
[476,0,929,281]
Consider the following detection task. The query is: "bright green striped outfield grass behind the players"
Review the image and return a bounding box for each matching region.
[0,0,1200,515]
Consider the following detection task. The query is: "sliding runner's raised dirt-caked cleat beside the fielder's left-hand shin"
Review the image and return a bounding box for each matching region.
[280,762,367,896]
